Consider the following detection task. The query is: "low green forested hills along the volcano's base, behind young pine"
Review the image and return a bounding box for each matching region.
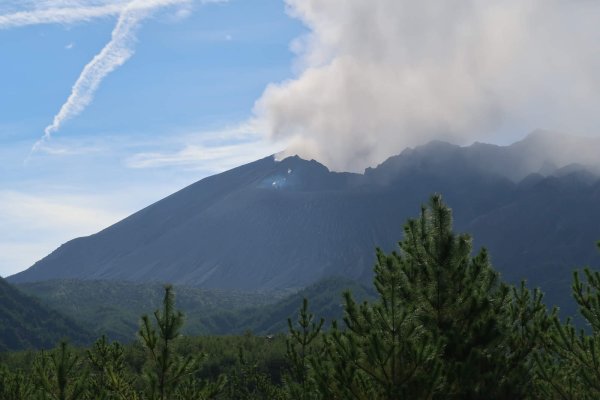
[18,278,373,342]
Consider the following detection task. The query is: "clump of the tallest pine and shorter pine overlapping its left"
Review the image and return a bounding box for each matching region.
[312,195,550,399]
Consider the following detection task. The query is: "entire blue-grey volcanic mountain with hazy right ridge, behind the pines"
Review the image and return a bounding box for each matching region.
[9,132,600,316]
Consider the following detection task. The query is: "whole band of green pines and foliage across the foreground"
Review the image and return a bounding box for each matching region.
[0,196,600,400]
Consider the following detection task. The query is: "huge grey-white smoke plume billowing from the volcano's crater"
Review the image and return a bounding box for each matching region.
[255,0,600,170]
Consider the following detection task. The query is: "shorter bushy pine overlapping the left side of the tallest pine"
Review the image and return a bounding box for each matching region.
[312,202,443,399]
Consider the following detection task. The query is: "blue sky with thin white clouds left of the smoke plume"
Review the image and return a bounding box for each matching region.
[0,0,305,276]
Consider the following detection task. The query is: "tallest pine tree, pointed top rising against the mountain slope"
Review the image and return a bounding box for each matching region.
[394,195,547,399]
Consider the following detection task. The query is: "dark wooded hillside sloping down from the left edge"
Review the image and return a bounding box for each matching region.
[0,278,92,351]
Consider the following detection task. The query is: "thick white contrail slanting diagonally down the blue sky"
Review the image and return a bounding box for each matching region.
[31,0,190,153]
